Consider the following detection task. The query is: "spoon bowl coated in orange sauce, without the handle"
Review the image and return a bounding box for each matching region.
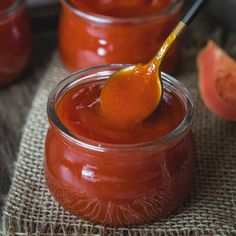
[100,61,162,127]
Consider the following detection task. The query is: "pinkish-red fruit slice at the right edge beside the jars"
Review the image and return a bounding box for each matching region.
[197,41,236,120]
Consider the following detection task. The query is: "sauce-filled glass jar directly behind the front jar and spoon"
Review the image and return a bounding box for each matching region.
[59,0,183,73]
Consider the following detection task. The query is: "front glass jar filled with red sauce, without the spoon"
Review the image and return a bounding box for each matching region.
[45,65,195,226]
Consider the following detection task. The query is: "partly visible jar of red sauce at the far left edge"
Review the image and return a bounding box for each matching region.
[0,0,31,85]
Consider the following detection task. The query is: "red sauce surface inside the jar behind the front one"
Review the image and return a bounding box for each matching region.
[71,0,173,18]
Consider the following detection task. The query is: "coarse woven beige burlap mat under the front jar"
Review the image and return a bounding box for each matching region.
[2,30,236,236]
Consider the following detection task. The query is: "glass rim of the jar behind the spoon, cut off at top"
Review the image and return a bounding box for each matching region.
[61,0,184,24]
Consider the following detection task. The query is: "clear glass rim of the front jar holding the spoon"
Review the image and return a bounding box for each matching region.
[47,64,194,152]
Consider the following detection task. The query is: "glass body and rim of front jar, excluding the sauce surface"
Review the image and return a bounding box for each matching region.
[45,65,195,226]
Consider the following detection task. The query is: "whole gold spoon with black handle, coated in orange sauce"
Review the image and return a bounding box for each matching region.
[100,0,208,126]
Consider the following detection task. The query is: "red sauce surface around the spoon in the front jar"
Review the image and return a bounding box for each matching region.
[56,81,185,144]
